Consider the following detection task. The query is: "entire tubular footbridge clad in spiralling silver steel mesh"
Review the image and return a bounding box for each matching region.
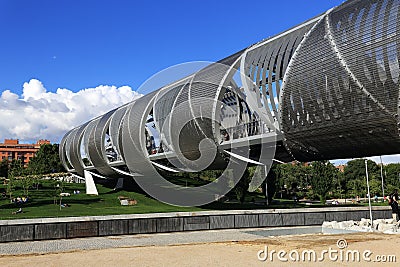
[60,0,400,205]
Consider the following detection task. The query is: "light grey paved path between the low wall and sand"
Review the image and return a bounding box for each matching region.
[0,226,321,255]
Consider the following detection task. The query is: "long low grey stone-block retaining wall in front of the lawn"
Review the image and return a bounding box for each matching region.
[0,207,392,242]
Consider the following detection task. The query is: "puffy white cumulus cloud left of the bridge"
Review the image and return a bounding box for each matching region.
[0,79,141,143]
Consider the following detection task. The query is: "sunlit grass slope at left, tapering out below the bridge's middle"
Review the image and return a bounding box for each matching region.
[0,182,202,220]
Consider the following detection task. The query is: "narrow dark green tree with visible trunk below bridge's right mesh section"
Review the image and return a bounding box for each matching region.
[311,161,337,204]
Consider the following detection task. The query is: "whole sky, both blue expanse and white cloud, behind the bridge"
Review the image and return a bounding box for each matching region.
[0,0,397,161]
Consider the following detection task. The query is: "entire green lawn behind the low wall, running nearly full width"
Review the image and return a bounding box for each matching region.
[0,181,387,220]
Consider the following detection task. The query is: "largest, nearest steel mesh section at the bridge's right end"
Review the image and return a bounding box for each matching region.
[281,0,400,161]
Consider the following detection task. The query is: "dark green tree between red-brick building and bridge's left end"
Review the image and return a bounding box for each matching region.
[27,144,65,174]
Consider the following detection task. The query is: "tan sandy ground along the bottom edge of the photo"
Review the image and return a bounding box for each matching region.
[0,233,400,267]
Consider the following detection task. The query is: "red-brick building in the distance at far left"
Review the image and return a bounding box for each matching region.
[0,139,50,166]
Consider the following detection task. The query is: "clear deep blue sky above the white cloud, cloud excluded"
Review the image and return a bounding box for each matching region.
[0,0,342,94]
